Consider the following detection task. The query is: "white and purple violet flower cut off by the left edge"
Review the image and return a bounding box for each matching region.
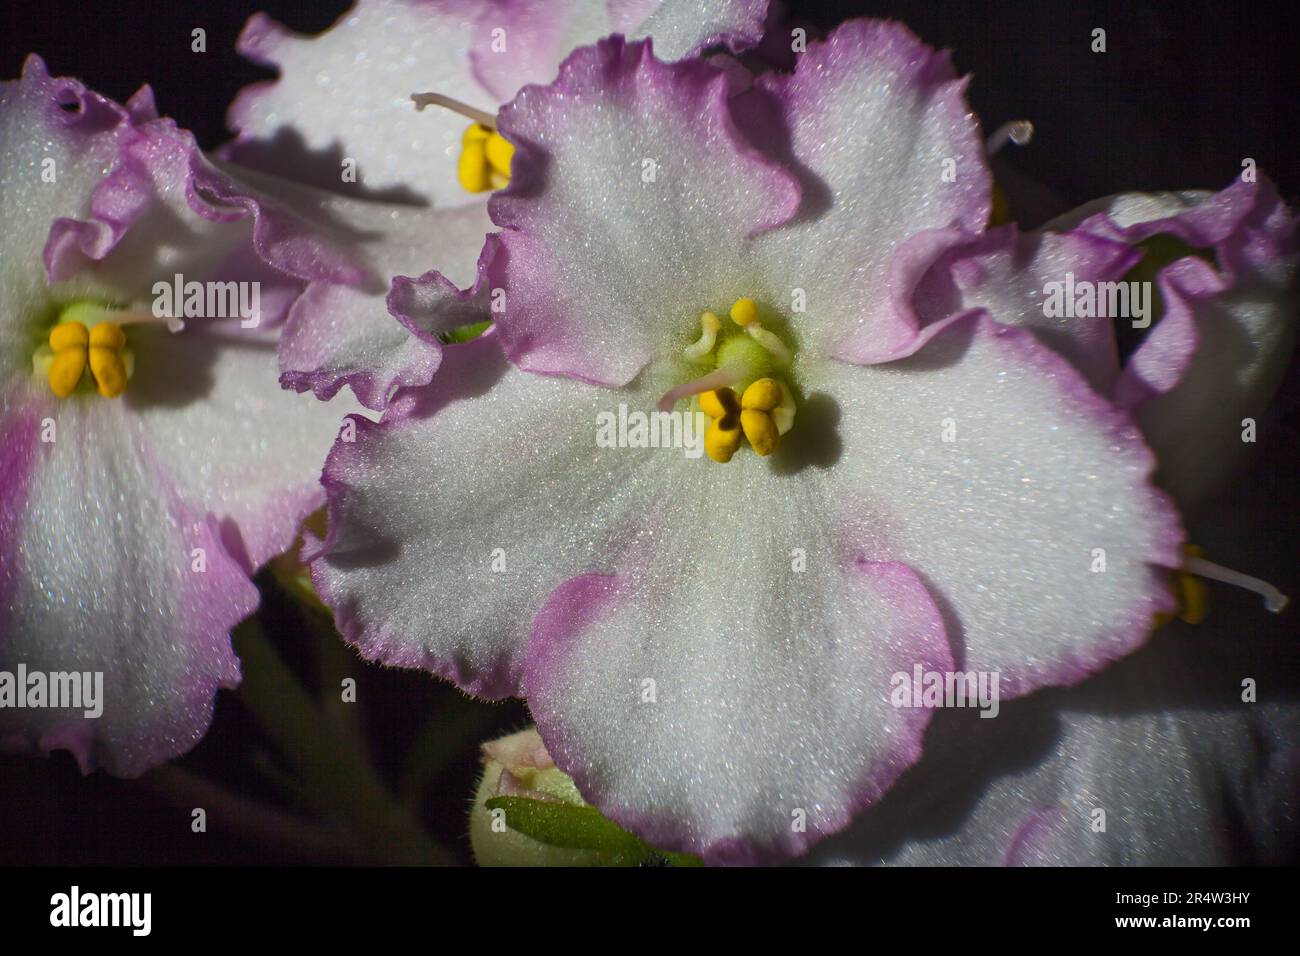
[0,57,356,775]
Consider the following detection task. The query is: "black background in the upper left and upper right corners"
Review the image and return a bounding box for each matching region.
[0,0,1300,203]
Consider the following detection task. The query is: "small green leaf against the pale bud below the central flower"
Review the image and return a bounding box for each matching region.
[486,796,701,866]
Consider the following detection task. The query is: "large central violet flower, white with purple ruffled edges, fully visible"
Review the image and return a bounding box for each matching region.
[304,22,1248,861]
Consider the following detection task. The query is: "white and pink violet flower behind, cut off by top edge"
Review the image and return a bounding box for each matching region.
[222,0,767,410]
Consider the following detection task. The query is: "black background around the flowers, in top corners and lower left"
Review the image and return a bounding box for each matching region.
[0,0,1300,865]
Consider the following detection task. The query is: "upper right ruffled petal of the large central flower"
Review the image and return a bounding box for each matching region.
[737,20,991,363]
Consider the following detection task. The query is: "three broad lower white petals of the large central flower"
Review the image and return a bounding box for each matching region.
[309,280,1180,861]
